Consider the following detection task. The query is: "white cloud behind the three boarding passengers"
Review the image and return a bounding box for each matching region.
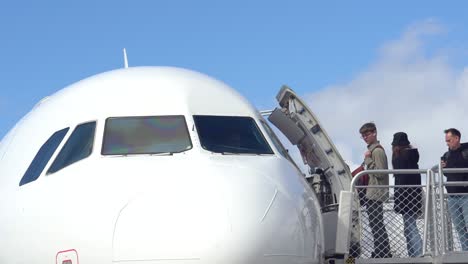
[305,20,468,168]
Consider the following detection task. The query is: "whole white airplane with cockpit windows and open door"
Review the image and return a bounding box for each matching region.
[0,66,351,264]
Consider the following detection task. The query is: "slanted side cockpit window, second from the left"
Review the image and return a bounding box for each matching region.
[47,122,96,174]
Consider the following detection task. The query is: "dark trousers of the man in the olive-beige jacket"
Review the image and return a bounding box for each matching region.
[367,200,390,258]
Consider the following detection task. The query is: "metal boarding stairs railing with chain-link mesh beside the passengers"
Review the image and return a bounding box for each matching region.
[338,165,468,263]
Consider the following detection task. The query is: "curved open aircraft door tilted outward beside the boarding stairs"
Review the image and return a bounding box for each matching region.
[268,86,352,201]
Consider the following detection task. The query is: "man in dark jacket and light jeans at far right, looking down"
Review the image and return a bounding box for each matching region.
[441,128,468,251]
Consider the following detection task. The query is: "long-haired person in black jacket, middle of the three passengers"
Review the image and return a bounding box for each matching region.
[392,132,422,257]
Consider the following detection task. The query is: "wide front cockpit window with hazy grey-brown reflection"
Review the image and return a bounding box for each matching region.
[101,116,192,155]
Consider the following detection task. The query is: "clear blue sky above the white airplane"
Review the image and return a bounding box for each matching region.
[0,0,468,167]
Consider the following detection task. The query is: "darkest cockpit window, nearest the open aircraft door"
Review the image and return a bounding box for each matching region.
[193,115,273,154]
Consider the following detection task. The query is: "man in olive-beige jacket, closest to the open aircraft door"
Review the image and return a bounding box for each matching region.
[359,123,392,258]
